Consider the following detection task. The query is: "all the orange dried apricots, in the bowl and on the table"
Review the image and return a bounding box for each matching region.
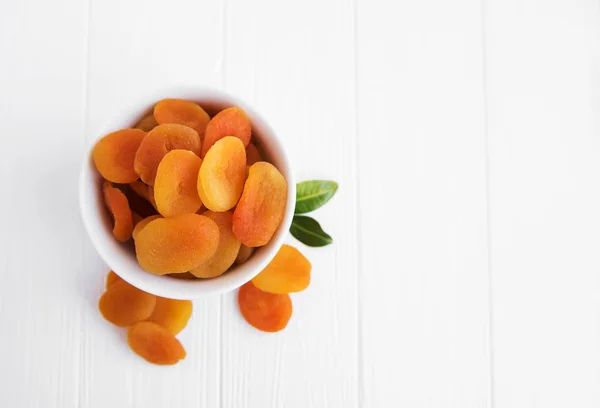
[92,99,311,364]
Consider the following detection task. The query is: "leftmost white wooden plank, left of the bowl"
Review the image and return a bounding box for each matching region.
[0,0,90,408]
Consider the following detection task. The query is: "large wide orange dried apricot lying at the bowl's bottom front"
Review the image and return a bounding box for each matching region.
[135,214,219,275]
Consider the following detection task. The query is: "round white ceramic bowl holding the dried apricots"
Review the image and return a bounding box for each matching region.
[79,87,296,299]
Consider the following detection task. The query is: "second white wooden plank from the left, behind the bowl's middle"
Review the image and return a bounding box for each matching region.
[83,0,223,407]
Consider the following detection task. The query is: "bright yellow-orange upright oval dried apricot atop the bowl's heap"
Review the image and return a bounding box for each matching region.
[197,136,246,211]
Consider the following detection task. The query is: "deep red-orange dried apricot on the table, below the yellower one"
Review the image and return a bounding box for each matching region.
[238,282,292,332]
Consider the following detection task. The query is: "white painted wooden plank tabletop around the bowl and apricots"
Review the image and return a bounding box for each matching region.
[0,0,600,408]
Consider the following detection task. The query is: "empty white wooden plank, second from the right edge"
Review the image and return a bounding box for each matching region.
[357,0,491,408]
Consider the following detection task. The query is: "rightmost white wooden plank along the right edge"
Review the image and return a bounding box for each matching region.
[485,0,600,408]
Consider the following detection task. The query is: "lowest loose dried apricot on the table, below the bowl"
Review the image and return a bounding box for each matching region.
[127,322,186,365]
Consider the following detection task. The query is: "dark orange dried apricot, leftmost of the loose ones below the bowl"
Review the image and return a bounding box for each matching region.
[98,279,156,327]
